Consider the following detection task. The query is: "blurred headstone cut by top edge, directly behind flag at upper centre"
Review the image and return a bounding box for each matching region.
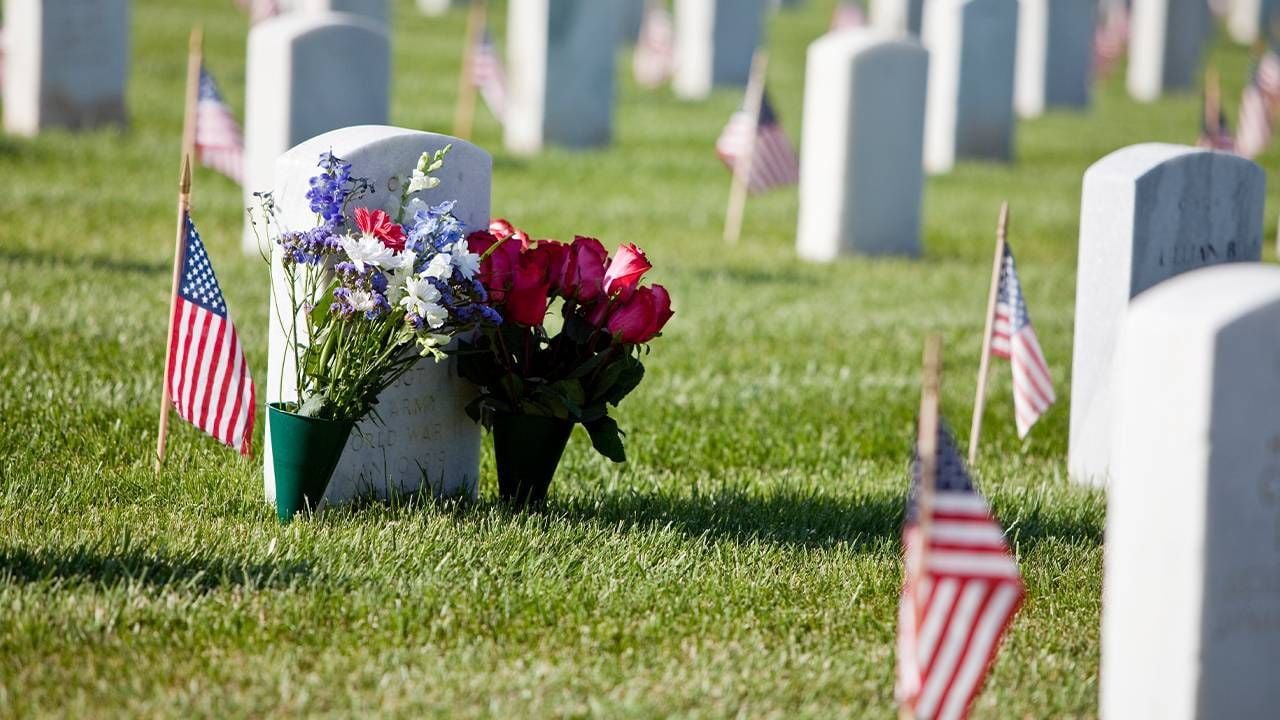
[671,0,767,100]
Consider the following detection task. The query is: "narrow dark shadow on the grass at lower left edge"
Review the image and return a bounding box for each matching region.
[0,546,311,593]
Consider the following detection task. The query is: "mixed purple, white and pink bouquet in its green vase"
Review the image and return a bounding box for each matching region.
[262,147,500,521]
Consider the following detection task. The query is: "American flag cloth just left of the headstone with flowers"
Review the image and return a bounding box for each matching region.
[165,215,255,455]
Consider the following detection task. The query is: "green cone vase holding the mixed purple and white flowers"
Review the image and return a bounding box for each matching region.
[266,402,356,525]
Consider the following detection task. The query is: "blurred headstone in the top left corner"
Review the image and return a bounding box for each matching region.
[0,0,129,136]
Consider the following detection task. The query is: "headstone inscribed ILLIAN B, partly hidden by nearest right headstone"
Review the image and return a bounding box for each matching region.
[1068,143,1266,484]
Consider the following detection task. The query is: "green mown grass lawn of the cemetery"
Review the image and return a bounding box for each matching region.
[0,0,1280,717]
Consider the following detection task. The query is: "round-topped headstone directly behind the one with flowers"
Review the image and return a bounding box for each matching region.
[243,13,390,255]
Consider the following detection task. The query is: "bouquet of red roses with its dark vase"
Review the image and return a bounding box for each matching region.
[458,220,673,505]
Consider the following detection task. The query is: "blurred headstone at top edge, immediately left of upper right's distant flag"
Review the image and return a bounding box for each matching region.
[1014,0,1098,118]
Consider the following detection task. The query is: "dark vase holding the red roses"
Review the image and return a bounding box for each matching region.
[493,413,573,507]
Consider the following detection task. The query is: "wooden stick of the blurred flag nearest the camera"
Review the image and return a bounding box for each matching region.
[899,334,942,720]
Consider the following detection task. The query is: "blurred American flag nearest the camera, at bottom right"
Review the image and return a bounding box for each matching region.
[896,424,1025,720]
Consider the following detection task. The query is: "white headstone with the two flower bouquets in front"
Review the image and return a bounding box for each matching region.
[264,126,493,502]
